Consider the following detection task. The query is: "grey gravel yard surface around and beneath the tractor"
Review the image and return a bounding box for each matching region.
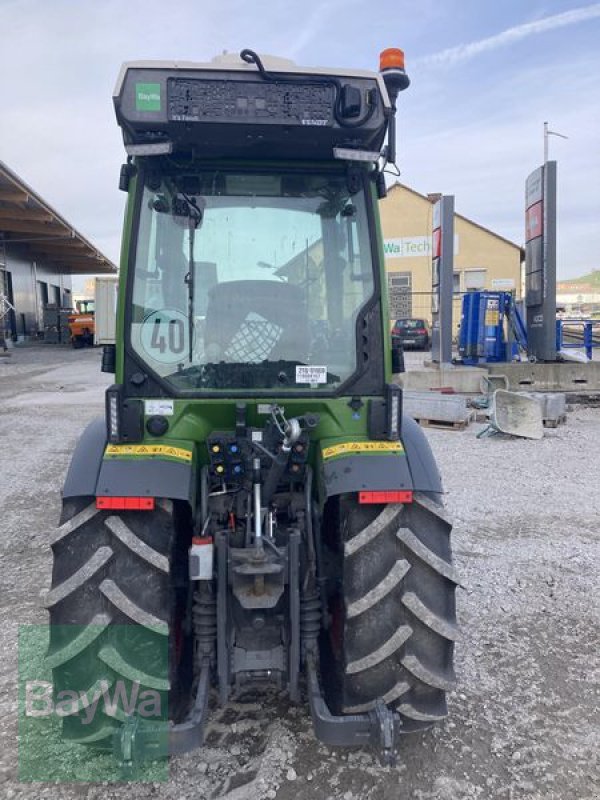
[0,346,600,800]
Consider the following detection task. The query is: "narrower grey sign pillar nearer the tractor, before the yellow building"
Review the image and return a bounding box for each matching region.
[431,195,454,364]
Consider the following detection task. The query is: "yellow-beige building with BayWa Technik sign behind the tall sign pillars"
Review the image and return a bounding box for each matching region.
[380,183,524,329]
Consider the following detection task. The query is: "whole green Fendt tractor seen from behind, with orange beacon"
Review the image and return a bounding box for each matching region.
[47,50,457,764]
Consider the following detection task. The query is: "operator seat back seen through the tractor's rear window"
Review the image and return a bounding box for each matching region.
[205,280,310,363]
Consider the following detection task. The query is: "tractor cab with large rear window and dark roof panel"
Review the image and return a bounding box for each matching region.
[115,51,404,406]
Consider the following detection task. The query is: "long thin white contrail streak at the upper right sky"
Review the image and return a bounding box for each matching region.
[415,3,600,66]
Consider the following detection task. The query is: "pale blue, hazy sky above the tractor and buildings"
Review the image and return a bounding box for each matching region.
[0,0,600,278]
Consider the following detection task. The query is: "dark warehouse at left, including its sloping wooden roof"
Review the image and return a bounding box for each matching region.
[0,161,117,341]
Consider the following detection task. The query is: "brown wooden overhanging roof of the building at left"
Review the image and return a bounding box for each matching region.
[0,161,117,275]
